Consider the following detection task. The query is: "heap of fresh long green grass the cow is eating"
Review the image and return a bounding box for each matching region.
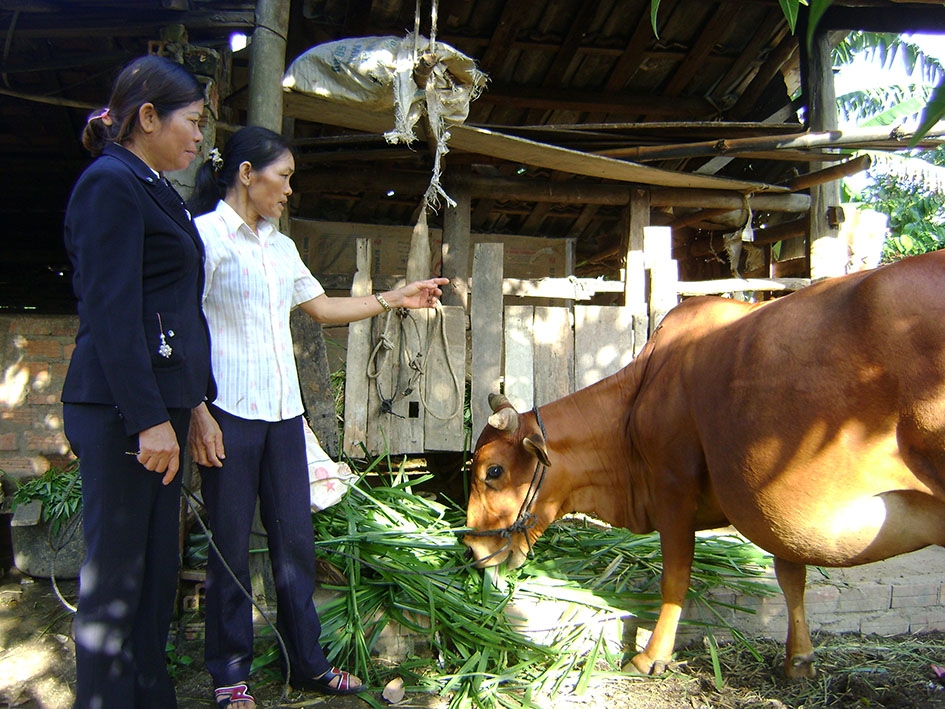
[304,470,770,707]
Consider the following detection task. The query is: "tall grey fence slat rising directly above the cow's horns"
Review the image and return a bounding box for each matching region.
[469,244,503,441]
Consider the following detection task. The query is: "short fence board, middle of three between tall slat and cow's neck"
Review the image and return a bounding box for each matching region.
[532,307,574,406]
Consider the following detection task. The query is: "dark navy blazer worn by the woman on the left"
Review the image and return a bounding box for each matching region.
[62,145,216,435]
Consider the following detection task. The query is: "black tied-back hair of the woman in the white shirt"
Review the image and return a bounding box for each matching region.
[187,126,292,216]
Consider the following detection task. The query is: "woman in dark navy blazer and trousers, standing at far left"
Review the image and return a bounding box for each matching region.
[62,56,223,709]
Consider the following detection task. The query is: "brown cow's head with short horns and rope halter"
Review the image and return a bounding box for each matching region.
[463,394,552,568]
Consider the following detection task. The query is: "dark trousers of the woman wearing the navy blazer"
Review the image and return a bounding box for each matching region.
[63,404,190,709]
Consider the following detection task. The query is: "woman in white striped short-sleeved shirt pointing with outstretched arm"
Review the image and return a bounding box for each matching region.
[190,127,447,709]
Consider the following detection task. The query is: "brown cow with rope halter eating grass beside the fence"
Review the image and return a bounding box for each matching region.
[464,252,945,677]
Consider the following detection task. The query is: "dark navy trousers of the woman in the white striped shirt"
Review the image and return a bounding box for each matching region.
[200,406,331,687]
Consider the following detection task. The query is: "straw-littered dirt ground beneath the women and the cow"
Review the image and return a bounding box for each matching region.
[0,569,945,709]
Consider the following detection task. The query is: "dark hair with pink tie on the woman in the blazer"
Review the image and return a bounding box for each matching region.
[82,55,204,156]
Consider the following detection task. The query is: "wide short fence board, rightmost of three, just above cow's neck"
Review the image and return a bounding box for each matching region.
[574,305,633,389]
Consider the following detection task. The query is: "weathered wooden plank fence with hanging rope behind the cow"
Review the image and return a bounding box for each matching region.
[344,227,806,457]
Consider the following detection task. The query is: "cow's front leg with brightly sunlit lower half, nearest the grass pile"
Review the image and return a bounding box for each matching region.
[627,530,696,675]
